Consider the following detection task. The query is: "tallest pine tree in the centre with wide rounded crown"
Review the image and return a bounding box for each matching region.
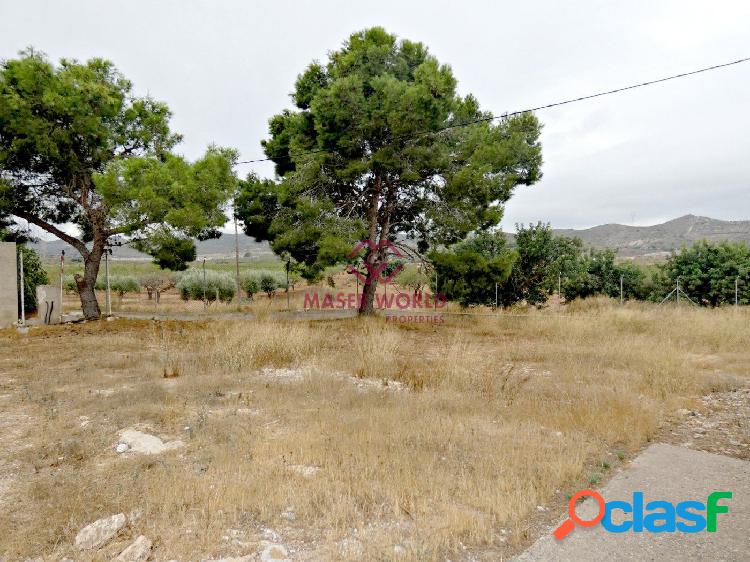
[237,27,542,314]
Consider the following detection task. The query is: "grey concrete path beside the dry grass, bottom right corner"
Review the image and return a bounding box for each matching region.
[515,443,750,562]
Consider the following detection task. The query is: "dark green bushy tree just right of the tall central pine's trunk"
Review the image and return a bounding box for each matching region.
[430,232,517,307]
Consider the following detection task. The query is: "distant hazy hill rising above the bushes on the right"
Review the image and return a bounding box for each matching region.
[555,215,750,257]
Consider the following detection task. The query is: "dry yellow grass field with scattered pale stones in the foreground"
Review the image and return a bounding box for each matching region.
[0,300,750,560]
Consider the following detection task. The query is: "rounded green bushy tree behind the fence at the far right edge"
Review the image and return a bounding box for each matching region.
[664,240,750,306]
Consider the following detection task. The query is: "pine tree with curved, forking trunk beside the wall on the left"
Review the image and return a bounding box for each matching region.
[0,49,236,318]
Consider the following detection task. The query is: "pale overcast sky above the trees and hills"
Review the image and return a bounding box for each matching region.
[0,0,750,230]
